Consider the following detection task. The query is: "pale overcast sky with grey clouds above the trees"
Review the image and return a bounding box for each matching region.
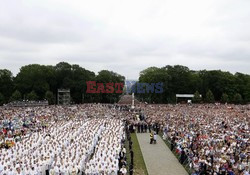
[0,0,250,79]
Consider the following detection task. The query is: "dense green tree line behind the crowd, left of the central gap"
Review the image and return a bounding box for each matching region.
[0,62,125,105]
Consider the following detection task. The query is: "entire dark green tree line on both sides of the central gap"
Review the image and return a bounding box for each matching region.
[0,62,250,105]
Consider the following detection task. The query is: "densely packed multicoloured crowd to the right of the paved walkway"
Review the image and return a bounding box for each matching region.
[137,104,250,175]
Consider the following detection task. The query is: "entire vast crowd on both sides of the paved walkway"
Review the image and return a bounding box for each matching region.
[0,104,250,175]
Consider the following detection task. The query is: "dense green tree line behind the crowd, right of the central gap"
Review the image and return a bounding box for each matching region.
[136,65,250,104]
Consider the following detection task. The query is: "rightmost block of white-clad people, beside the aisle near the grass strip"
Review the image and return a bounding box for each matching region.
[85,119,126,175]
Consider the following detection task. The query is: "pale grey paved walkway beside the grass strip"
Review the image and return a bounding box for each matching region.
[136,133,188,175]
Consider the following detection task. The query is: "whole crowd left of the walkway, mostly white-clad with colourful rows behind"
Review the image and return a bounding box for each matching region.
[0,105,127,175]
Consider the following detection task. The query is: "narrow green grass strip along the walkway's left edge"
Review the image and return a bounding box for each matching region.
[131,133,148,175]
